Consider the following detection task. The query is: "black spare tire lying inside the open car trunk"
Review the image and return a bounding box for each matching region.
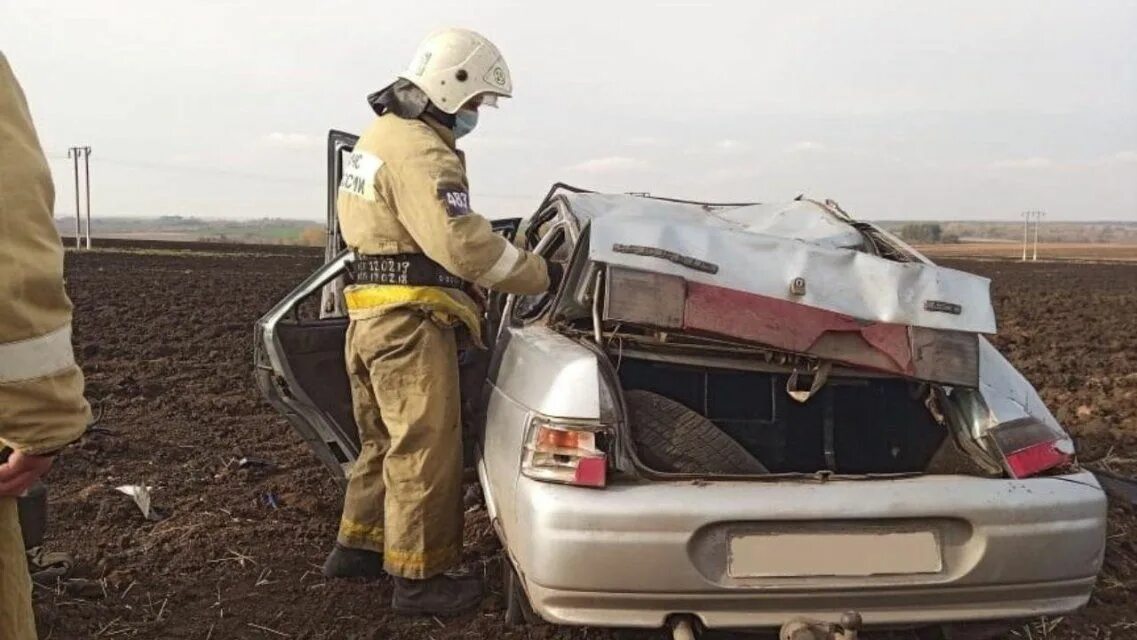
[624,390,770,475]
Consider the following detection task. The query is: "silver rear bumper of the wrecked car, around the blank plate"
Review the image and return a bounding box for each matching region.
[504,473,1105,627]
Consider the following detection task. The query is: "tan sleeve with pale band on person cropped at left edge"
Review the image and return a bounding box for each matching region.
[0,53,90,454]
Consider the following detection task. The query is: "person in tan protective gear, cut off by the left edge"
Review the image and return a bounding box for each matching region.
[0,52,90,640]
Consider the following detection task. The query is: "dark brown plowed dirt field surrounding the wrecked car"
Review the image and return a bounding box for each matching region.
[36,246,1137,640]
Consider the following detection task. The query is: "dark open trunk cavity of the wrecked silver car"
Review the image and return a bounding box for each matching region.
[613,356,973,474]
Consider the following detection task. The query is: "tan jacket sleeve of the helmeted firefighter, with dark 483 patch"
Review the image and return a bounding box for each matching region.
[387,123,549,294]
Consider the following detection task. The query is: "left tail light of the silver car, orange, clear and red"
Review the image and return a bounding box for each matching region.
[521,416,608,487]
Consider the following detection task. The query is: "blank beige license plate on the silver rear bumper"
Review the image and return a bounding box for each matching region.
[728,531,944,577]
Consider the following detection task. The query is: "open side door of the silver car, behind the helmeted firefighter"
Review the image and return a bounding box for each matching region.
[254,131,520,481]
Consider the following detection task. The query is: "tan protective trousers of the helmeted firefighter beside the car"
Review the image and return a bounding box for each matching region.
[339,308,463,579]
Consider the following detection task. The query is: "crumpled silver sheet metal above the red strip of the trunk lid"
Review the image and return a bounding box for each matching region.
[565,193,996,333]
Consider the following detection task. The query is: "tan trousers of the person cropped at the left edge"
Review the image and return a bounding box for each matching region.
[0,498,35,640]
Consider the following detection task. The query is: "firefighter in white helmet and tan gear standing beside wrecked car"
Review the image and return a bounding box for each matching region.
[324,28,561,614]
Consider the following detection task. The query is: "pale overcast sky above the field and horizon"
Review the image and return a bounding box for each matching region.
[0,0,1137,221]
